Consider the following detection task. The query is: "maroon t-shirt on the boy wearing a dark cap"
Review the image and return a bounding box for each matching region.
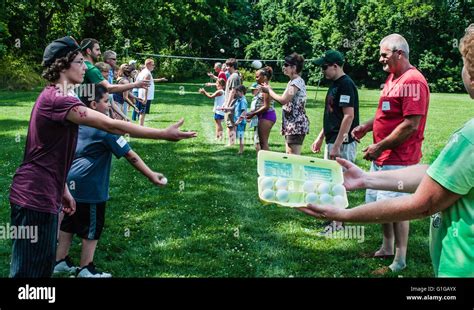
[10,86,84,214]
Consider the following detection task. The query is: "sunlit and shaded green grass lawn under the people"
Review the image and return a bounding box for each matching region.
[0,83,474,277]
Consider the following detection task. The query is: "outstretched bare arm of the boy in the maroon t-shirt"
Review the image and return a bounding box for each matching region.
[66,106,197,141]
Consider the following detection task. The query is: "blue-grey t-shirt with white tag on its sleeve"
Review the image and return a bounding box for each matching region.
[67,126,131,203]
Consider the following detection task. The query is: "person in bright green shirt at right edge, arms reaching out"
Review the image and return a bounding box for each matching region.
[300,24,474,277]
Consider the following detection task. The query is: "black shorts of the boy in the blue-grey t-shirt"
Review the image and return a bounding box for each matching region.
[61,202,106,240]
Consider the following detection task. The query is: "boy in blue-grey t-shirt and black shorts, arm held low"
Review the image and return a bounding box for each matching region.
[54,84,167,278]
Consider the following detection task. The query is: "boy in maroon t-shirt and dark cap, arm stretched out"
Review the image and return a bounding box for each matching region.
[10,37,196,278]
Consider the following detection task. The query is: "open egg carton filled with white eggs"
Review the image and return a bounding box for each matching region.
[258,151,349,208]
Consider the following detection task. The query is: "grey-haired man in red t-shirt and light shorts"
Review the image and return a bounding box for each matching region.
[352,34,430,274]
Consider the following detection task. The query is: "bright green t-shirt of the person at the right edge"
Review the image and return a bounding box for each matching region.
[427,119,474,277]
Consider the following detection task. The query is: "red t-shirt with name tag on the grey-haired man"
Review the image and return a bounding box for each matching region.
[373,67,430,166]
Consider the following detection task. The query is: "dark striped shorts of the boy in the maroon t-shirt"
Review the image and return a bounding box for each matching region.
[10,204,58,278]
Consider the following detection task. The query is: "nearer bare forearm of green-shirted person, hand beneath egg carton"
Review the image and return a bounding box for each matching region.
[301,174,461,223]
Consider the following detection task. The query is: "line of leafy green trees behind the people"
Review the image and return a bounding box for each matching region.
[0,0,474,92]
